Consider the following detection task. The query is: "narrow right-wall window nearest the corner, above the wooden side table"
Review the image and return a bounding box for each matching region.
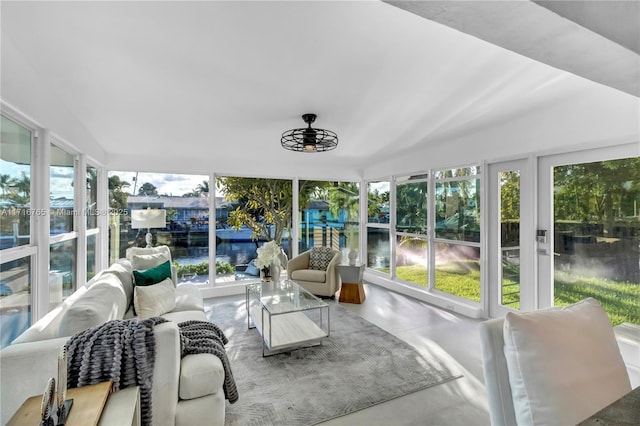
[367,180,391,274]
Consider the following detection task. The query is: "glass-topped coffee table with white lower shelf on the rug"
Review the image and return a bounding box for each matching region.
[246,280,330,356]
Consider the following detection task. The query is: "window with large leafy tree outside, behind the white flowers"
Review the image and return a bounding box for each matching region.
[216,176,293,282]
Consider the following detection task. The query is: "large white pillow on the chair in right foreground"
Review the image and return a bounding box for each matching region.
[503,298,631,425]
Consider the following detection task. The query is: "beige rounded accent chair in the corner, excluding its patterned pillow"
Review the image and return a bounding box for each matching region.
[287,249,342,297]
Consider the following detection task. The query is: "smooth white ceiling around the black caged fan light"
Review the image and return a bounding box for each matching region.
[0,1,638,178]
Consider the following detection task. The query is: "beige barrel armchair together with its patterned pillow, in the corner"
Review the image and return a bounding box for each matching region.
[287,247,342,297]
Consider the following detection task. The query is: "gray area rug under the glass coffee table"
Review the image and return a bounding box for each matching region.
[207,300,461,426]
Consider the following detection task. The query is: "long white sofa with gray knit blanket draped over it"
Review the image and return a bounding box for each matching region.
[0,253,225,425]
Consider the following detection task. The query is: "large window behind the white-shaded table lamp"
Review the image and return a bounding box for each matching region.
[108,171,210,283]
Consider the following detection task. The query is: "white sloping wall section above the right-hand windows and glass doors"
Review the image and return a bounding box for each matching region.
[363,86,640,179]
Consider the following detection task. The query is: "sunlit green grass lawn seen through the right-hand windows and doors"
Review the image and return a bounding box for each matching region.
[392,261,640,326]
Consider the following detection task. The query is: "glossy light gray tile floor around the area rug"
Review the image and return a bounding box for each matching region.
[205,284,490,426]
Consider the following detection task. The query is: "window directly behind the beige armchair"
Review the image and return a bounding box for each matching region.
[298,180,360,261]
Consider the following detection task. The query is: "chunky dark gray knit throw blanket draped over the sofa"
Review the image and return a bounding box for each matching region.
[65,317,238,425]
